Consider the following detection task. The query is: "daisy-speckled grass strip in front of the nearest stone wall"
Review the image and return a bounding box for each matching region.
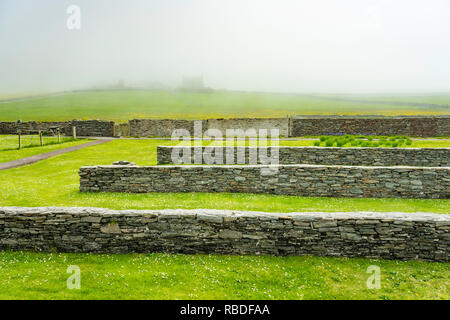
[0,252,450,300]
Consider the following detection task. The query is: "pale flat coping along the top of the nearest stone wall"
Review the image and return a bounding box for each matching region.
[0,207,450,224]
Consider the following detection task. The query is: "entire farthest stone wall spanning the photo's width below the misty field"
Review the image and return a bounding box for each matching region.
[0,116,450,137]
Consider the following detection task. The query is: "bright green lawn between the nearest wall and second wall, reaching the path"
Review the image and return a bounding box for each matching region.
[0,140,450,213]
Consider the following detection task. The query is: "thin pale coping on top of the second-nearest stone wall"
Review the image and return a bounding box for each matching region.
[80,164,450,171]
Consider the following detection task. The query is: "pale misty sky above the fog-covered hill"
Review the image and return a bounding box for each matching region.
[0,0,450,94]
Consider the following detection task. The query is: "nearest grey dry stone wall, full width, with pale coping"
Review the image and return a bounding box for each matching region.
[0,207,450,261]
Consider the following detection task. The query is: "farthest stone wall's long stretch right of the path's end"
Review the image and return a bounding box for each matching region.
[130,116,450,137]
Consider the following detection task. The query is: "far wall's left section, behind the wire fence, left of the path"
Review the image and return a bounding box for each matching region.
[0,120,114,137]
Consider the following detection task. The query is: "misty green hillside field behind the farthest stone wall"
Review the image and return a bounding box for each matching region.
[0,90,450,121]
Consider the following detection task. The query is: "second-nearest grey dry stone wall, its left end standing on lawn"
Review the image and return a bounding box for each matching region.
[79,165,450,199]
